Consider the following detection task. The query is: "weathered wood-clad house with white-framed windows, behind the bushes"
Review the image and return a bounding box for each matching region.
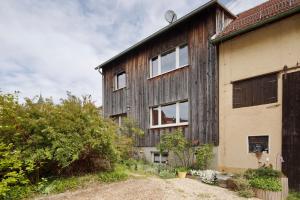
[96,0,235,164]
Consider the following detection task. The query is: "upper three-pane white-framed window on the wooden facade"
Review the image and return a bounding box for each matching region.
[150,45,189,78]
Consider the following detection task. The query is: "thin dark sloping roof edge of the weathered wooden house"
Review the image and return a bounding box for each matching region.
[95,0,235,70]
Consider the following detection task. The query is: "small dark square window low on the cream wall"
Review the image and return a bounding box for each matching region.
[248,135,269,153]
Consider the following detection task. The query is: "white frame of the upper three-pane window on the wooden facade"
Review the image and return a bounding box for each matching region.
[149,44,189,78]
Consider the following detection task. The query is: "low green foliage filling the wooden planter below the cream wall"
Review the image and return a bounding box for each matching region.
[249,177,281,192]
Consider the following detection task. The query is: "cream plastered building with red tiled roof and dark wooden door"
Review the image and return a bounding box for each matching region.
[213,0,300,191]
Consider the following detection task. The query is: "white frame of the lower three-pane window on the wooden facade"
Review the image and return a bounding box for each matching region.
[150,101,189,128]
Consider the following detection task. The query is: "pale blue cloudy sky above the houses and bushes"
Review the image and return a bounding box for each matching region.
[0,0,265,105]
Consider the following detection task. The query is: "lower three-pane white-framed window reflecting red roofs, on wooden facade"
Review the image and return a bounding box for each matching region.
[150,101,189,128]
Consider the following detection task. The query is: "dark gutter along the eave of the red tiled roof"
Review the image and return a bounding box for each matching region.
[210,6,300,44]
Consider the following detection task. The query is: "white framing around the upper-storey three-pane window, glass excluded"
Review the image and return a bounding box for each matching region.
[149,43,190,79]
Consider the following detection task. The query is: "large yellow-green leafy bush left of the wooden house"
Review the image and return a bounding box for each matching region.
[0,93,119,182]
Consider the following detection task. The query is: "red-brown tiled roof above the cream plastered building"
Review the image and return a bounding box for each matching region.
[212,0,300,43]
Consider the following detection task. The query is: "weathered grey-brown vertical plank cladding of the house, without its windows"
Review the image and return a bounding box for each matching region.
[102,3,231,147]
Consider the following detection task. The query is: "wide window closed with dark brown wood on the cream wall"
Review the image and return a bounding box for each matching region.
[233,74,277,108]
